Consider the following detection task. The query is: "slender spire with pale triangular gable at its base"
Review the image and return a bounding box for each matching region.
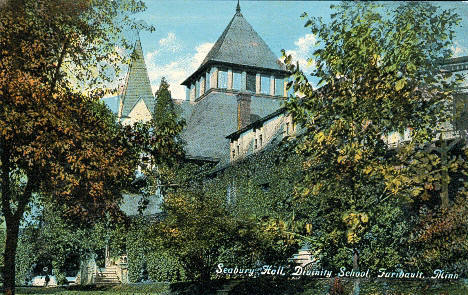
[117,38,155,124]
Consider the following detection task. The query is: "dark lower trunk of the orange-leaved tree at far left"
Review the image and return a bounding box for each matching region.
[3,216,19,295]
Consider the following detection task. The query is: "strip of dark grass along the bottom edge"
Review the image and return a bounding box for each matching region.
[12,279,468,295]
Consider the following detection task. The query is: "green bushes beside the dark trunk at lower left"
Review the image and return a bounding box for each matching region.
[11,203,122,285]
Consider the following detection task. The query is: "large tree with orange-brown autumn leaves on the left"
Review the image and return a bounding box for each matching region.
[0,0,150,294]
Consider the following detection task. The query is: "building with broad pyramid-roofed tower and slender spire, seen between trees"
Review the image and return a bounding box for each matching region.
[101,0,468,282]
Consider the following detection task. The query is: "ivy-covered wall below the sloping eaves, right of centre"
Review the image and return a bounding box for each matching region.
[205,146,301,222]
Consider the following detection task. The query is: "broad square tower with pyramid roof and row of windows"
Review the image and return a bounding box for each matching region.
[182,3,288,161]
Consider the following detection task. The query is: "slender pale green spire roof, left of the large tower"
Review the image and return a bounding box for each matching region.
[118,37,155,118]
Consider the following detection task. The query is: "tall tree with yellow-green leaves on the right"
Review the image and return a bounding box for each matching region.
[285,2,459,290]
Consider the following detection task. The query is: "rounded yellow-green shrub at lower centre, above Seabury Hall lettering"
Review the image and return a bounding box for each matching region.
[151,184,264,282]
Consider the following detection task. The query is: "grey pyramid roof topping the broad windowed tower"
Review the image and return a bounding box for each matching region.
[182,2,286,85]
